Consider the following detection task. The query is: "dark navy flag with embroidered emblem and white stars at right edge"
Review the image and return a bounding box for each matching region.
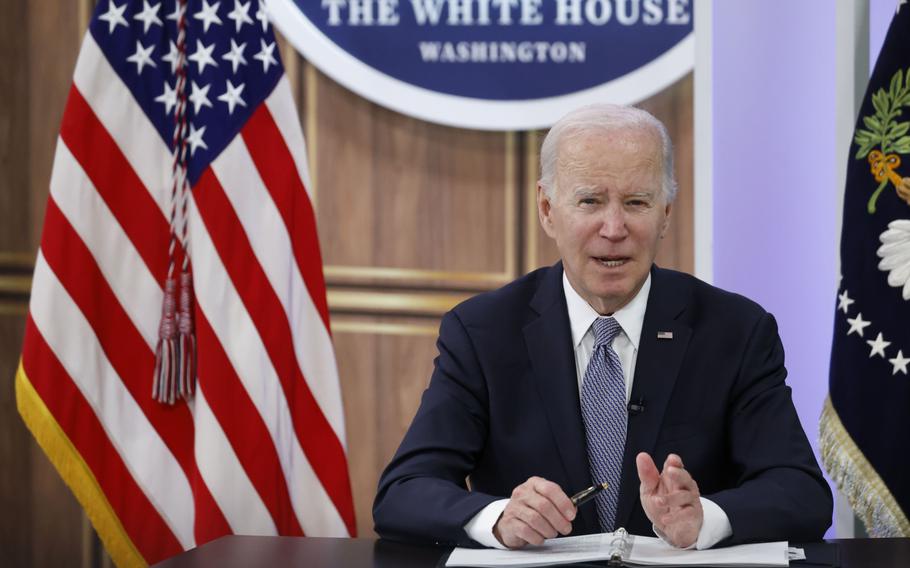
[820,5,910,537]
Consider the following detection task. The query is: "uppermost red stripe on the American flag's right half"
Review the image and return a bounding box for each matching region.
[240,105,329,329]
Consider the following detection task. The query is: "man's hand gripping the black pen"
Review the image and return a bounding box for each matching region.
[493,477,575,548]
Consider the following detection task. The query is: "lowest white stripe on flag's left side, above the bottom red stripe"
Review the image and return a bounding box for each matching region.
[26,251,194,546]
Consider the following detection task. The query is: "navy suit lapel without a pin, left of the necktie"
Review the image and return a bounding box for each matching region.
[523,264,598,533]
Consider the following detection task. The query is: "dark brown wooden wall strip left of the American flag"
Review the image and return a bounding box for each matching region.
[0,0,102,567]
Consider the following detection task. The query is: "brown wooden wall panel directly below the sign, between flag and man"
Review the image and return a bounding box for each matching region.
[306,65,517,289]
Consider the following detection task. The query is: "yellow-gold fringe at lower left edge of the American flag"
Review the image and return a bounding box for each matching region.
[16,360,148,568]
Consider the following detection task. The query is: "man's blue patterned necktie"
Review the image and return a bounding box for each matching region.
[581,317,628,532]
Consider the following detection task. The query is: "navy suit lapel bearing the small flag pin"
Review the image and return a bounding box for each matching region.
[616,267,692,526]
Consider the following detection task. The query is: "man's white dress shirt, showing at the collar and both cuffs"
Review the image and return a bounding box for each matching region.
[464,272,733,550]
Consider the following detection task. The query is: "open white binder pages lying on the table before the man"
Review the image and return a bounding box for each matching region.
[446,533,789,567]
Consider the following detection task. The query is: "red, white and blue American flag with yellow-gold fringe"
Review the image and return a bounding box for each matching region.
[16,0,356,565]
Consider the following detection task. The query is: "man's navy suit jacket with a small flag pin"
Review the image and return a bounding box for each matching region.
[373,263,832,546]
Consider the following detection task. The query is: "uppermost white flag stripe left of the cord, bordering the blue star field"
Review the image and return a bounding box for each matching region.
[73,34,173,218]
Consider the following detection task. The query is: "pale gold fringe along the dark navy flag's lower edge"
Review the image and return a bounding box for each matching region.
[819,396,910,538]
